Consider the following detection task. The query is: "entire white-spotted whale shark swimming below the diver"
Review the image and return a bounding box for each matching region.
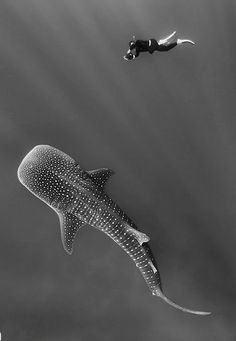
[17,145,210,315]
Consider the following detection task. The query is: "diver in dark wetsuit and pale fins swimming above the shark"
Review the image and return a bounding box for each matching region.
[124,31,195,61]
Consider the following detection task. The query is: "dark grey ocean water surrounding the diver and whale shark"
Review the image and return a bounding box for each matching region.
[0,0,236,341]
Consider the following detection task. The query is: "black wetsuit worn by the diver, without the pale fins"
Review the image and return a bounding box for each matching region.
[130,39,177,57]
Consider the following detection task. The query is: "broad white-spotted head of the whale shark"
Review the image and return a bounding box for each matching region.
[17,145,75,205]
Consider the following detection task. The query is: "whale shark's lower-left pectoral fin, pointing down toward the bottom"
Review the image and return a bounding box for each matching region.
[57,211,84,255]
